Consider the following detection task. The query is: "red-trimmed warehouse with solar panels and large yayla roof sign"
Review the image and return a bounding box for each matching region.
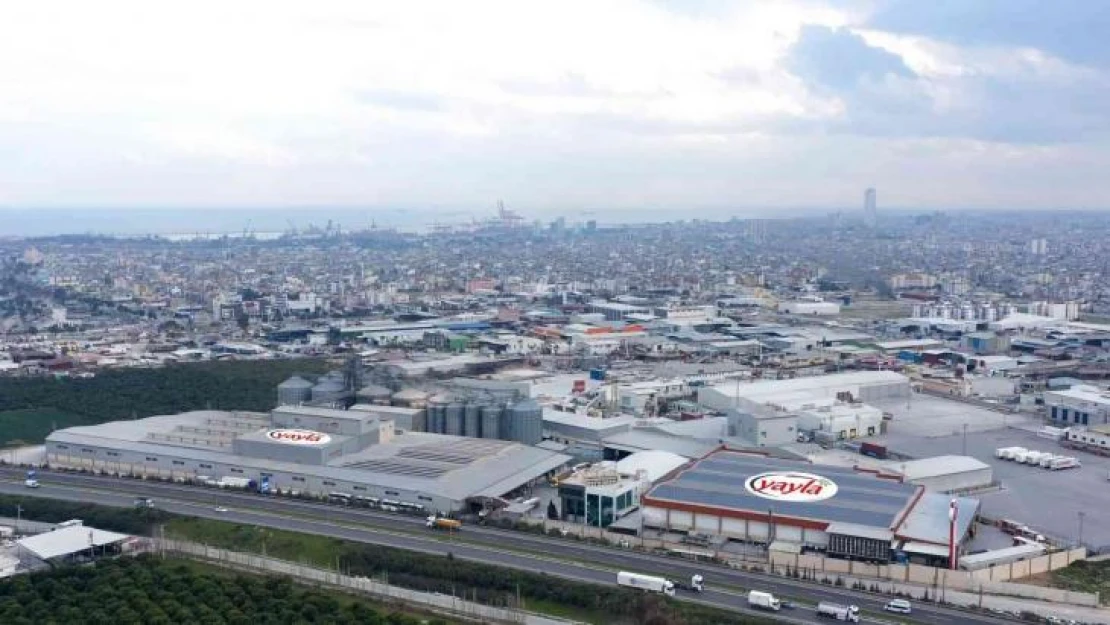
[642,450,979,564]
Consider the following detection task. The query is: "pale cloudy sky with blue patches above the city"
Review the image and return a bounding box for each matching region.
[0,0,1110,214]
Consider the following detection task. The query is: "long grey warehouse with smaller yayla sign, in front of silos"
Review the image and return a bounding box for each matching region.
[46,405,571,513]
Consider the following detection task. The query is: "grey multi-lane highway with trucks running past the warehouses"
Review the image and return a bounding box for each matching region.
[0,467,1009,624]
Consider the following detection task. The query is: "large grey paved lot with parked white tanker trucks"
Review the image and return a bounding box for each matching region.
[882,426,1110,547]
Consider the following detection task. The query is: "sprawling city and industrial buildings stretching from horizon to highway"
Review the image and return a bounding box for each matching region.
[0,202,1110,622]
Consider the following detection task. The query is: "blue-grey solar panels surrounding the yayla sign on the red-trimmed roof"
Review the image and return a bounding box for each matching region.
[648,452,915,528]
